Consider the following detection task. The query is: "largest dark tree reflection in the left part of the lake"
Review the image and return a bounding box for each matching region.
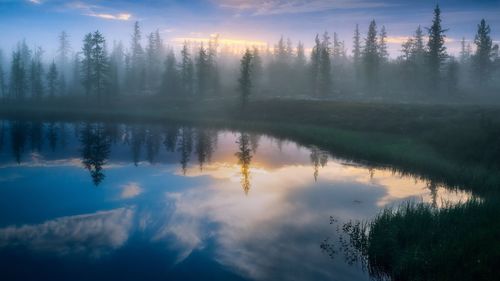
[80,123,111,186]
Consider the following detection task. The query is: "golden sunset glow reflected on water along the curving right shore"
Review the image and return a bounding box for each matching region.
[169,130,471,205]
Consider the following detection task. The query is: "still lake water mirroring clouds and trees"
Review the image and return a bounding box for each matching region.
[0,120,469,280]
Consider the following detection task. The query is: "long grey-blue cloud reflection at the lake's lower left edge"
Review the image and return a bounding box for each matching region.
[0,208,134,257]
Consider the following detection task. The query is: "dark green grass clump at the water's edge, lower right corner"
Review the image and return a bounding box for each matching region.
[351,200,500,280]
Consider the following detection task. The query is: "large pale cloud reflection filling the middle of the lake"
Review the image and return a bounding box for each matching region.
[156,162,467,280]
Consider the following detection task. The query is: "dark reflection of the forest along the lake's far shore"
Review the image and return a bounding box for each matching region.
[0,121,356,189]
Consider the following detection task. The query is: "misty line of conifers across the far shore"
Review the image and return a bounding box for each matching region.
[0,6,500,105]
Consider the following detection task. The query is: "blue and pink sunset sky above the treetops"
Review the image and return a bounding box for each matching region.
[0,0,500,57]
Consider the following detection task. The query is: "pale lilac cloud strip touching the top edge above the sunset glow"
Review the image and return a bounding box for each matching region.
[217,0,388,16]
